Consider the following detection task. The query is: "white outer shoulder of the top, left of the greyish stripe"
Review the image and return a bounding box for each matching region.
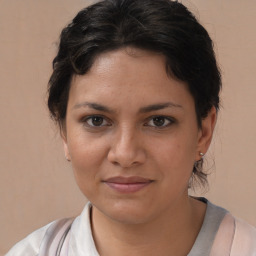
[5,221,55,256]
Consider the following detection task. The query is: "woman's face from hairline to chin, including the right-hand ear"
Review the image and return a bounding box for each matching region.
[63,48,215,223]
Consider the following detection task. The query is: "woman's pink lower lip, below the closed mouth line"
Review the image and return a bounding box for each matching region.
[105,182,151,193]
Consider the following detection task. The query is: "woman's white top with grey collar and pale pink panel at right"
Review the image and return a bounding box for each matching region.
[6,200,256,256]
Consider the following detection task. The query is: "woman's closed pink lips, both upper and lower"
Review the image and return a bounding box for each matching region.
[104,176,153,193]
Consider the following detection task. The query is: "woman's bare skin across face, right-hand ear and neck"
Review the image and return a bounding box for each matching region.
[62,48,216,256]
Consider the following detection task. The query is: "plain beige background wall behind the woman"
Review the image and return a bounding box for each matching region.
[0,0,256,255]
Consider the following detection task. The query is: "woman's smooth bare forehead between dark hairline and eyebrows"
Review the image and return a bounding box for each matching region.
[69,48,193,112]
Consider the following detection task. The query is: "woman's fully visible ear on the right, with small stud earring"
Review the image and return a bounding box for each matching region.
[196,107,217,161]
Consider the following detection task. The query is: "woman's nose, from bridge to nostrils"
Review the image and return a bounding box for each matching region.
[108,128,146,168]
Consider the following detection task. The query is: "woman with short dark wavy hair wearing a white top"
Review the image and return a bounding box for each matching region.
[7,0,256,256]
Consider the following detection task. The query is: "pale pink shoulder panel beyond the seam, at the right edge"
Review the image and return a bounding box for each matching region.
[231,218,256,256]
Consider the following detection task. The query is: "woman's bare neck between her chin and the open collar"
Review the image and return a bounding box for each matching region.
[92,196,206,256]
